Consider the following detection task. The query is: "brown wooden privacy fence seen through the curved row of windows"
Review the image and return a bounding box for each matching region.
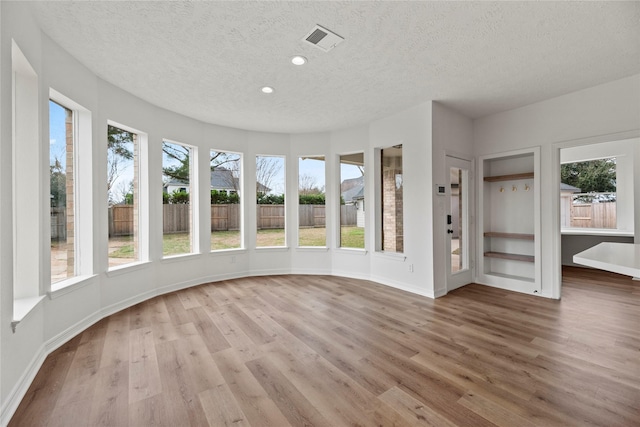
[110,204,357,238]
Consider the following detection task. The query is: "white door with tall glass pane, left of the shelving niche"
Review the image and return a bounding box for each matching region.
[445,156,473,291]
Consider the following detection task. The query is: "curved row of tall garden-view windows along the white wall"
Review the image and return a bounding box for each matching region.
[49,98,403,287]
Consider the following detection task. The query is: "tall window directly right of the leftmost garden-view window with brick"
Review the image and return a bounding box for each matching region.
[107,124,140,268]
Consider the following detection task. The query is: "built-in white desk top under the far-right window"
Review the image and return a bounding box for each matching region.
[573,242,640,280]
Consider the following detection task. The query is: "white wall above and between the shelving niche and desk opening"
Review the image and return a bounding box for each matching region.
[474,75,640,298]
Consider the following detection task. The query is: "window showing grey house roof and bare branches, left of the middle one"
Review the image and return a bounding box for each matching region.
[210,150,242,251]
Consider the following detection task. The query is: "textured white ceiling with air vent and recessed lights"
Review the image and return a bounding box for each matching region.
[27,1,640,133]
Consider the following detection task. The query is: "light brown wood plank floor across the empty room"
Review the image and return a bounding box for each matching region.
[10,268,640,427]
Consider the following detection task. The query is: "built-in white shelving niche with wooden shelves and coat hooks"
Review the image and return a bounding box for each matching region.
[478,147,540,293]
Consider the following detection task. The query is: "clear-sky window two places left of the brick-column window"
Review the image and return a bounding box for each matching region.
[298,156,327,246]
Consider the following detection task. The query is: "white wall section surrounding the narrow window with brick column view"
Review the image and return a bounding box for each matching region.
[365,102,434,297]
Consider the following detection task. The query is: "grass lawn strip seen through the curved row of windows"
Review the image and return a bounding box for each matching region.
[109,227,364,259]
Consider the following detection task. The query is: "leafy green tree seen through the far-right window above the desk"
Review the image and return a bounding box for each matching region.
[560,158,616,193]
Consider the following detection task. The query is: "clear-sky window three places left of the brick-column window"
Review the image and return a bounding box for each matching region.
[256,156,286,247]
